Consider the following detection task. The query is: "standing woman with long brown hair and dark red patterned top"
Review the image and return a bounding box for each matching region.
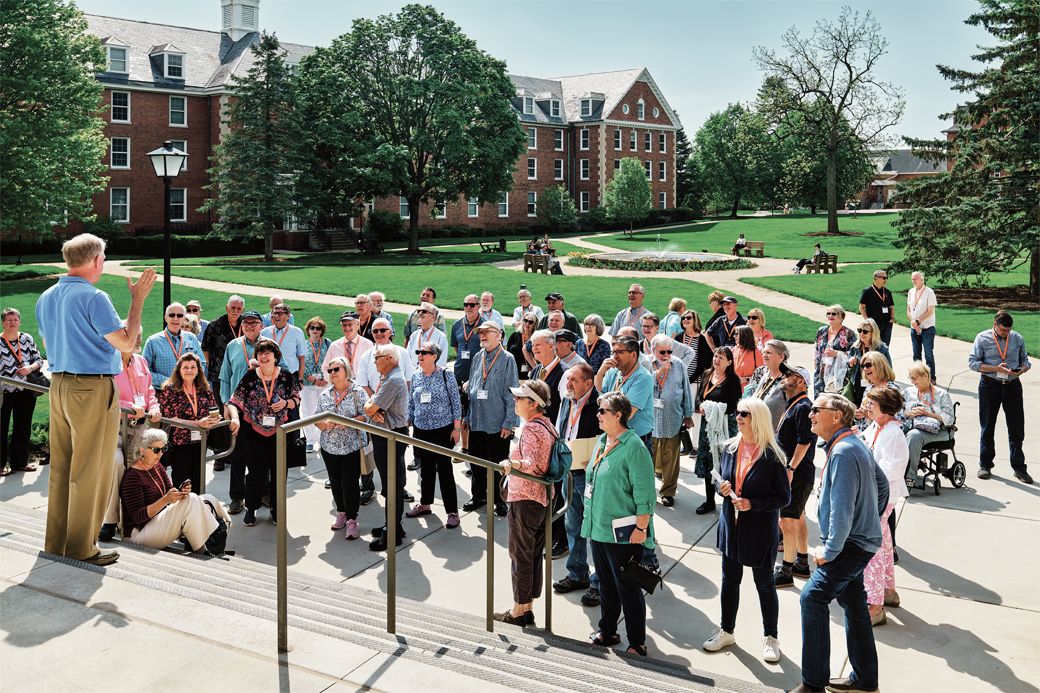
[159,353,220,488]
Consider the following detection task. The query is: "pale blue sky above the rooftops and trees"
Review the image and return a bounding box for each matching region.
[76,0,991,137]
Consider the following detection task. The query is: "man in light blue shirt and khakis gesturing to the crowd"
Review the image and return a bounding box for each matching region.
[36,233,155,565]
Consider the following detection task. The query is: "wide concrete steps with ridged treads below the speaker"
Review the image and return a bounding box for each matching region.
[0,505,771,692]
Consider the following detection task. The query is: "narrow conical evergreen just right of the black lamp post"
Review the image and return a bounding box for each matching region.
[203,33,301,262]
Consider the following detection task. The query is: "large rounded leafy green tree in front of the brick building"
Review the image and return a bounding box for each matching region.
[301,4,525,253]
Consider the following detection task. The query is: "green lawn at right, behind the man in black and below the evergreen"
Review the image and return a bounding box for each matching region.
[740,264,1040,356]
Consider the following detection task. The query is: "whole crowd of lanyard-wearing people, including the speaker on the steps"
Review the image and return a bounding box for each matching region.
[6,234,1032,691]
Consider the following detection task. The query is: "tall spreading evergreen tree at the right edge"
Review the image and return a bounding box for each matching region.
[896,0,1040,294]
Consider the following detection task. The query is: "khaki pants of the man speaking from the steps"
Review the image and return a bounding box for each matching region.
[44,373,120,559]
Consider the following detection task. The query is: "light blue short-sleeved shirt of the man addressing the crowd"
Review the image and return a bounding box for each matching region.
[36,276,123,376]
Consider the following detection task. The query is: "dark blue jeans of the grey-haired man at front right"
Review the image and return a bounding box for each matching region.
[801,541,878,691]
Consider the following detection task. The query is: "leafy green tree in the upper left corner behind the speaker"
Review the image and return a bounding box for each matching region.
[0,0,108,236]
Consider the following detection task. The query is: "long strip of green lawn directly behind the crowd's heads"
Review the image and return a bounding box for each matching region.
[156,264,818,341]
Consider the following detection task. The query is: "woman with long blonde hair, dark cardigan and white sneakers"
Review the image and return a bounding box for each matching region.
[703,397,790,663]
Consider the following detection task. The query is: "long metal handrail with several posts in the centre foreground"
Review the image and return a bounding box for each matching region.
[275,412,574,652]
